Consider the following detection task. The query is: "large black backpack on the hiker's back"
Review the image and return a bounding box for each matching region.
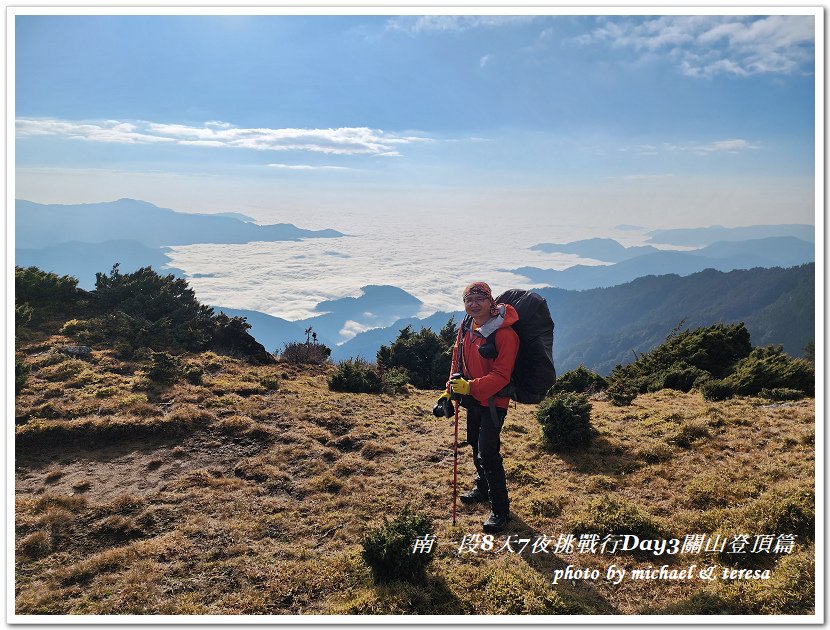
[461,289,556,404]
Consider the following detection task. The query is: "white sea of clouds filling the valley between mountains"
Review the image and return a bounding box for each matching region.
[168,205,643,340]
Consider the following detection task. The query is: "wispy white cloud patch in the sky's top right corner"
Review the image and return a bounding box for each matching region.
[570,15,815,77]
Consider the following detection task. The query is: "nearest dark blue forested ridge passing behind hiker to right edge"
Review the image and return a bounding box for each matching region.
[264,264,815,374]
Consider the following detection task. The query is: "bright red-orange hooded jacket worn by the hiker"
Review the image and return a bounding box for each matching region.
[450,304,519,409]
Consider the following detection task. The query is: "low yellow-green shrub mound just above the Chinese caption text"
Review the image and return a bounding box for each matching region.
[570,495,670,539]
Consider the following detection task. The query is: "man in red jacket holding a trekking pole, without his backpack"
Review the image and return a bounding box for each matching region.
[441,282,519,533]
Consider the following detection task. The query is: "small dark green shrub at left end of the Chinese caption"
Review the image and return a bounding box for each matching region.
[361,508,434,582]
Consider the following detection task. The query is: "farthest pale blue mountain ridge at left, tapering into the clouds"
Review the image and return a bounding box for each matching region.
[15,199,345,249]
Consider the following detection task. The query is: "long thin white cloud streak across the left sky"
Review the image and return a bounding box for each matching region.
[16,118,430,156]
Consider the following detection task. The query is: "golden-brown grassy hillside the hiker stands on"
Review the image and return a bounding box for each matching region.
[15,325,815,615]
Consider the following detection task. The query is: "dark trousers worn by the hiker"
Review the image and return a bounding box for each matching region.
[467,404,510,514]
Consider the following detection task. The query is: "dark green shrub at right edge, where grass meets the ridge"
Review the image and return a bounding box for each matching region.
[724,346,816,396]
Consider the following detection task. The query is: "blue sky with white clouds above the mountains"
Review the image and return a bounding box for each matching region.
[15,15,815,227]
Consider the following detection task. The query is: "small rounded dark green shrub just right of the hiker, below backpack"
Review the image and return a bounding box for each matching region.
[536,392,593,451]
